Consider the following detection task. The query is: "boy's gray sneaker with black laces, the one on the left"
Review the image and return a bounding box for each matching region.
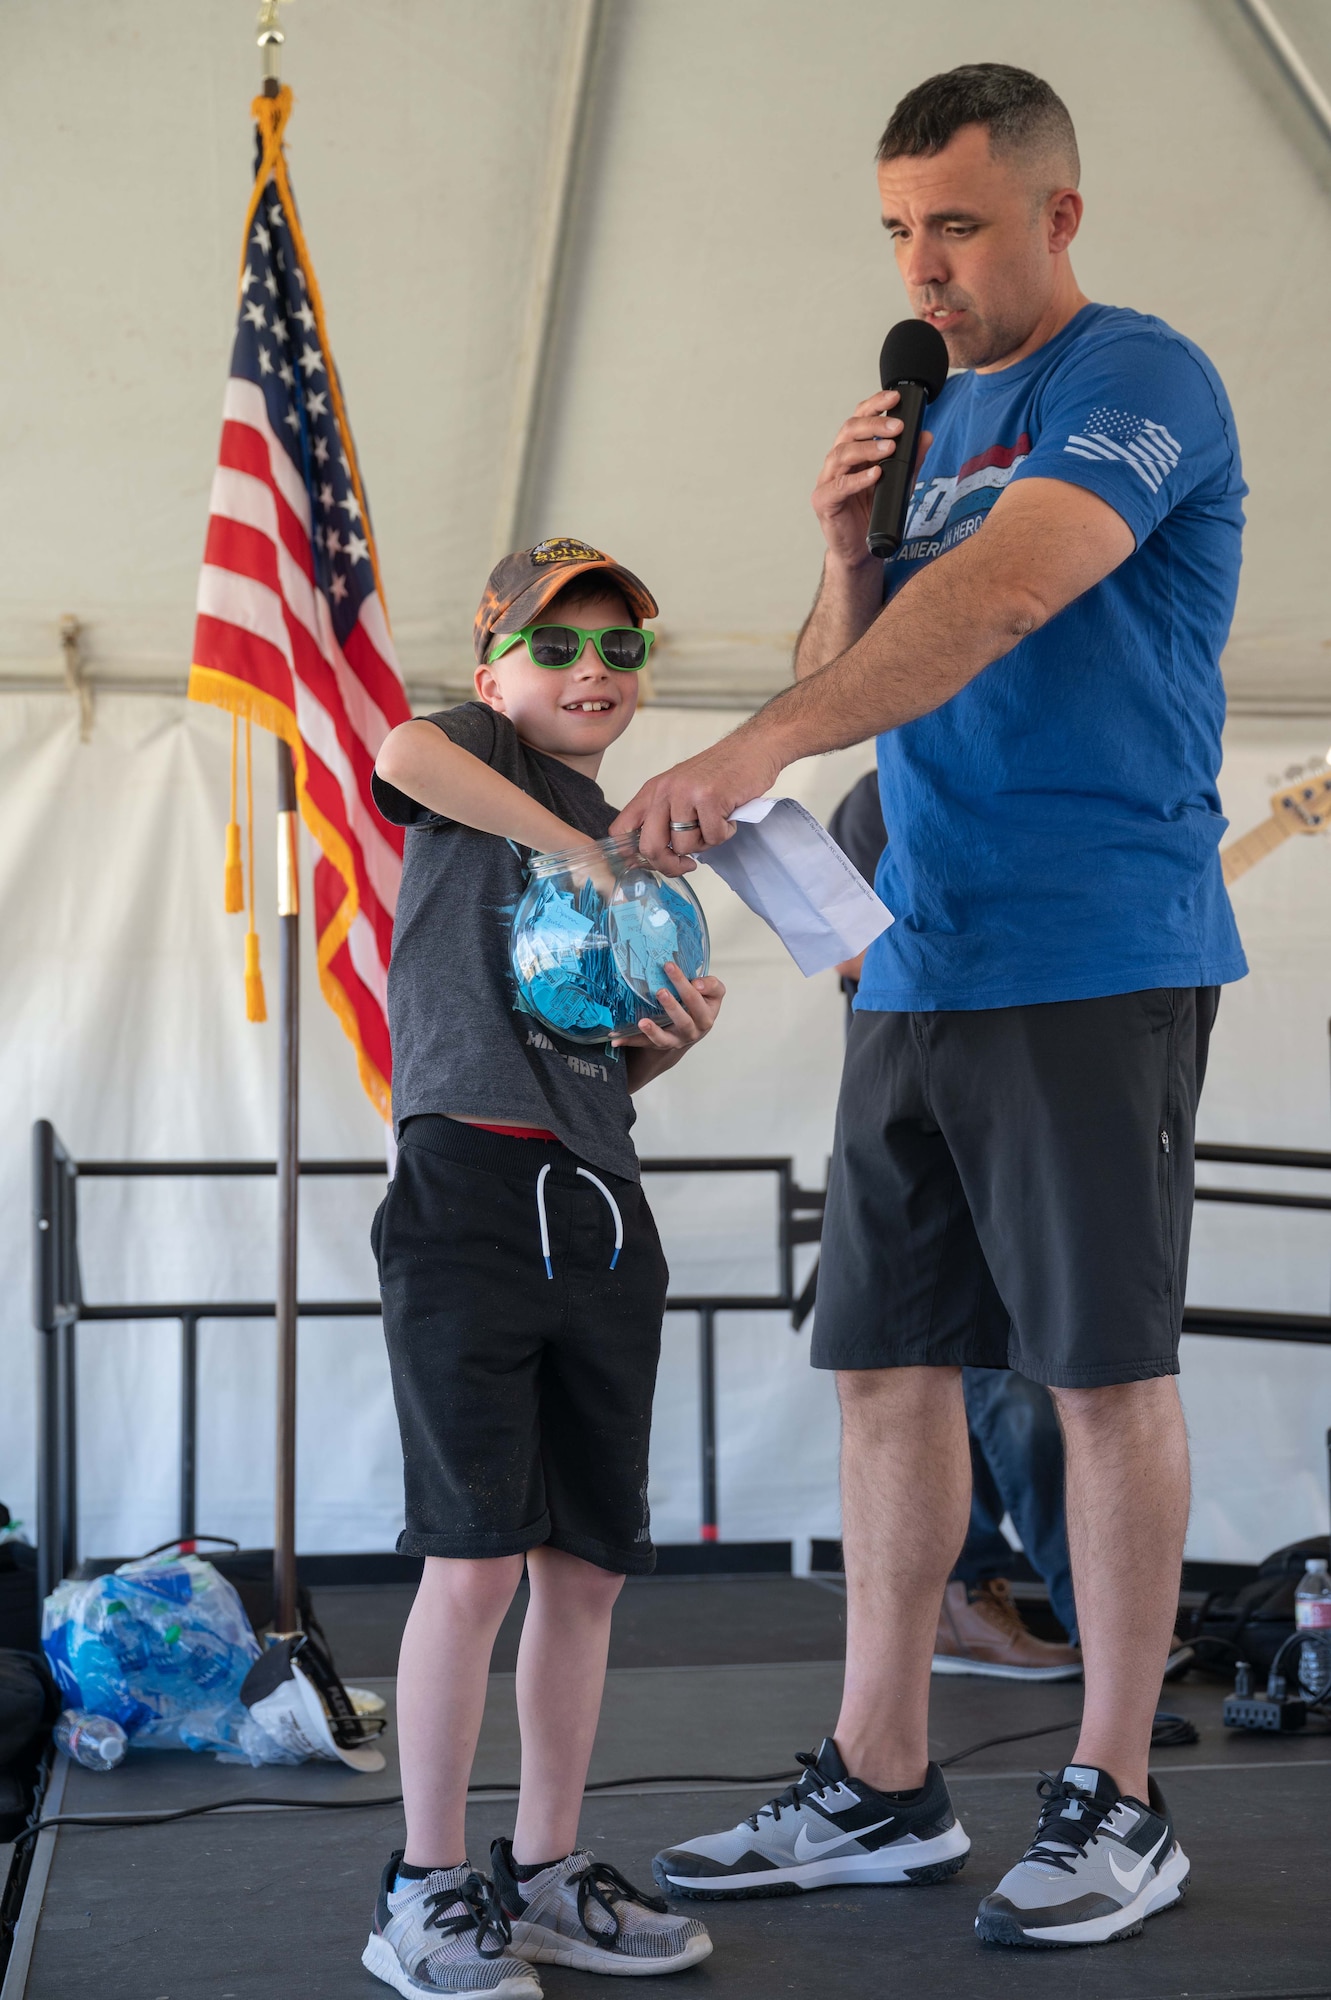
[360,1854,542,2000]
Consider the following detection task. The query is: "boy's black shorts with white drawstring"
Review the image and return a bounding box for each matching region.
[370,1118,667,1576]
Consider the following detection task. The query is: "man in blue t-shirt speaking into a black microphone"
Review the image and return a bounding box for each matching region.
[616,64,1247,1944]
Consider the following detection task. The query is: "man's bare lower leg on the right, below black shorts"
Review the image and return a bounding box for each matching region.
[1051,1376,1189,1798]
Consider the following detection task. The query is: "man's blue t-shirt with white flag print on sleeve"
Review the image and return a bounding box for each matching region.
[855,306,1247,1010]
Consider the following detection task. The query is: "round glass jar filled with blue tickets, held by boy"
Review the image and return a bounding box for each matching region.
[512,834,711,1046]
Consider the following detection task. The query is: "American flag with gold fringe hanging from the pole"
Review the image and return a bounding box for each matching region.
[190,88,403,1118]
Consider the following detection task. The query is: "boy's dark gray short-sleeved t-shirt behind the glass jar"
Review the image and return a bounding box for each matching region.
[374,702,638,1180]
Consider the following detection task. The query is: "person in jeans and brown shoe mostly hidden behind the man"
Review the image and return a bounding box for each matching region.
[827,772,1081,1680]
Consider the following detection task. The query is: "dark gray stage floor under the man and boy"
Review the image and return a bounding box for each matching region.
[2,1578,1331,2000]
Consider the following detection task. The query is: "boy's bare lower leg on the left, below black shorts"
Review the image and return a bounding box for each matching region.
[398,1556,522,1868]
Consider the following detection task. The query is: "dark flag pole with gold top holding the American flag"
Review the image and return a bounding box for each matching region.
[258,0,300,1632]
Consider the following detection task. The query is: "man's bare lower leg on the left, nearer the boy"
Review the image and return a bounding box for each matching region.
[835,1368,971,1792]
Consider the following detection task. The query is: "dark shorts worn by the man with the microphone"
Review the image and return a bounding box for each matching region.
[811,986,1219,1388]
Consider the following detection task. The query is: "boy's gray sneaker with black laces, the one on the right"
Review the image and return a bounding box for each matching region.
[490,1840,711,1978]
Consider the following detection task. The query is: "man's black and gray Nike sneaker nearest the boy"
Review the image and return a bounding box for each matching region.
[652,1736,971,1900]
